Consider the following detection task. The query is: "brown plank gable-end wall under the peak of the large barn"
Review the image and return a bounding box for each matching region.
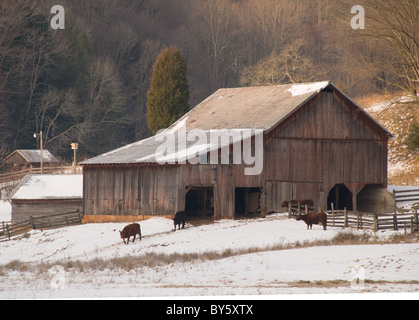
[265,92,388,211]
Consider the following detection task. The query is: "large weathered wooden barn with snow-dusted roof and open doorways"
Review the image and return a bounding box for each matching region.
[81,82,392,219]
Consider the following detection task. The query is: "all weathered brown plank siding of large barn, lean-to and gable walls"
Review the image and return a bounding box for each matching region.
[83,91,388,218]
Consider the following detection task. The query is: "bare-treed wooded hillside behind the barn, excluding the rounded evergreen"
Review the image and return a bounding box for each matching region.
[0,0,419,160]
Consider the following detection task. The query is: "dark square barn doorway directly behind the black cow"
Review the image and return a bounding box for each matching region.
[185,187,214,217]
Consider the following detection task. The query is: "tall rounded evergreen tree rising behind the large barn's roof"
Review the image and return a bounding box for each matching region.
[147,47,189,134]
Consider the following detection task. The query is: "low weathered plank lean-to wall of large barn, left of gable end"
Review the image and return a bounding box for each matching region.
[83,165,262,218]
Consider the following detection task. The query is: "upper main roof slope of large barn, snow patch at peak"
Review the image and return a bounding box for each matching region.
[172,82,330,131]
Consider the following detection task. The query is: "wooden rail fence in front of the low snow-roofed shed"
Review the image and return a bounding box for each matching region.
[0,211,83,241]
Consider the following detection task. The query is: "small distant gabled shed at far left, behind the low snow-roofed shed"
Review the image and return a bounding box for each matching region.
[3,150,60,172]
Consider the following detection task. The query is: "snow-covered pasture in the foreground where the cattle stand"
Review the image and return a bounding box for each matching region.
[0,210,419,299]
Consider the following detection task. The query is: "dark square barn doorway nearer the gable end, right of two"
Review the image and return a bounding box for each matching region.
[235,188,262,217]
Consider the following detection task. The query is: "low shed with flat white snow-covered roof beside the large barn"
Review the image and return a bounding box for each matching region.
[9,175,83,223]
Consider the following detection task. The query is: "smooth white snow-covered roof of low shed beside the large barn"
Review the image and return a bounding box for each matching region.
[9,174,83,200]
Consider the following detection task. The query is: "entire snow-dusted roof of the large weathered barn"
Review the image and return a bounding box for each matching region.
[81,81,391,165]
